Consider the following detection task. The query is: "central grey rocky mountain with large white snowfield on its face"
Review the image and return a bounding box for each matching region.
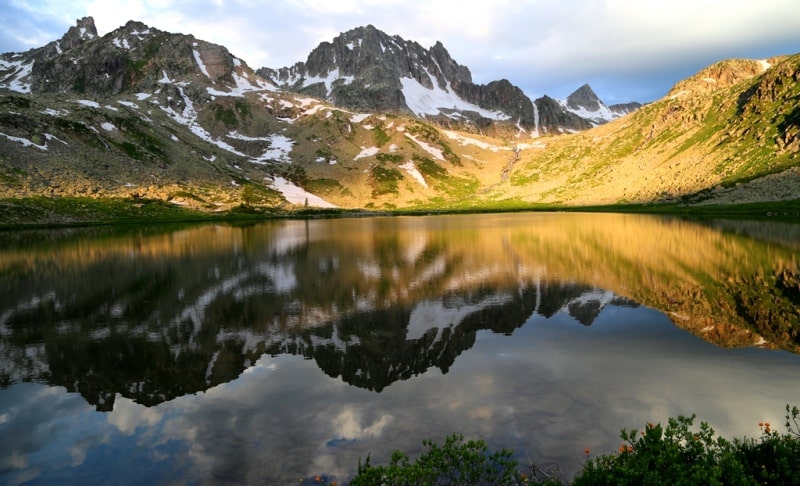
[257,25,633,134]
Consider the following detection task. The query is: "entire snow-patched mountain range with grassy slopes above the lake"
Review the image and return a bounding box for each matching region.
[0,17,800,224]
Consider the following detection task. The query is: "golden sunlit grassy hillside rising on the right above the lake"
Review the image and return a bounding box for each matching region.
[492,55,800,204]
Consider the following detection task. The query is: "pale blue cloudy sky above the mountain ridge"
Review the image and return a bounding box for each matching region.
[0,0,800,104]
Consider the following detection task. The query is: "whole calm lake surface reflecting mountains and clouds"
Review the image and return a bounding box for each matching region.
[0,214,800,484]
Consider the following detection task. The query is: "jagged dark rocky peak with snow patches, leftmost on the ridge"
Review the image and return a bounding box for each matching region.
[0,17,274,96]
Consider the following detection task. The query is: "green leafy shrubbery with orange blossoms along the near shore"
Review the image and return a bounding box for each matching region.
[350,405,800,486]
